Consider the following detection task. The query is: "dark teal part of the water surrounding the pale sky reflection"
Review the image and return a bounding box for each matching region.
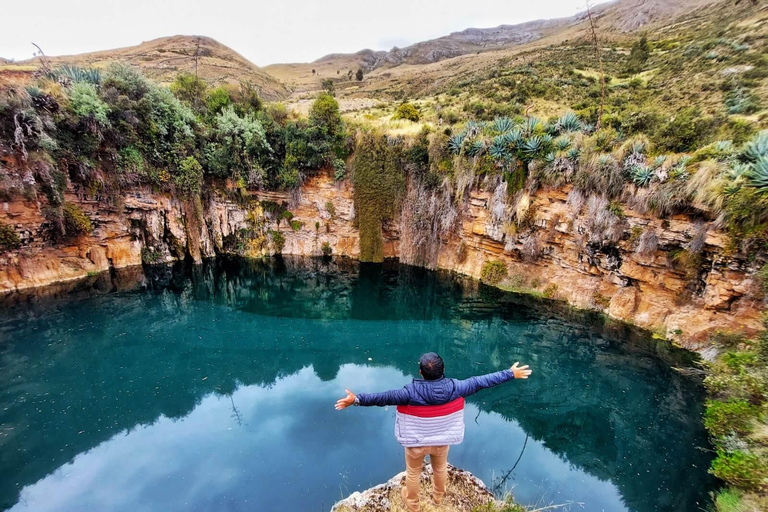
[0,259,708,511]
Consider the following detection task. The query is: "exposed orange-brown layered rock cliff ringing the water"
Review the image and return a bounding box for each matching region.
[0,174,763,349]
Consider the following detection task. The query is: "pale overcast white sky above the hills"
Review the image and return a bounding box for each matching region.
[0,0,605,66]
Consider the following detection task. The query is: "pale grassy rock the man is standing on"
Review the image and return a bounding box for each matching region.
[331,464,502,512]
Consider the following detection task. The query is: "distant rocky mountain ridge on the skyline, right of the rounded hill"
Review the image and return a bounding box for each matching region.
[264,0,718,90]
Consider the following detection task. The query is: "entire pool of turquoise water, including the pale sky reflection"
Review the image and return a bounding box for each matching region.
[0,259,714,512]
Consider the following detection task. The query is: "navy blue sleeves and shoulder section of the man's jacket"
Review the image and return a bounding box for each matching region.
[357,370,515,406]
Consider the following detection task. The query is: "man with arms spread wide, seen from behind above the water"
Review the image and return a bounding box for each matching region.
[336,352,531,512]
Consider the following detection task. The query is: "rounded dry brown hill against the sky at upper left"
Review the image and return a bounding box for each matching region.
[0,35,288,100]
